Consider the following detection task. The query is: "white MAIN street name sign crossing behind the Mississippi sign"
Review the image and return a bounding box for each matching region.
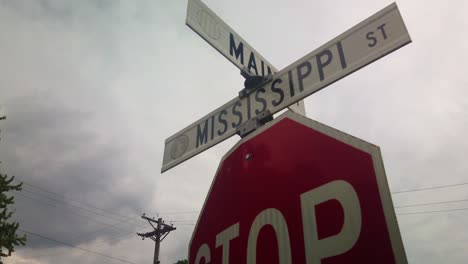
[185,0,305,115]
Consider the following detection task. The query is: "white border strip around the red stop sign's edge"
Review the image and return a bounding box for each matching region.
[188,111,408,264]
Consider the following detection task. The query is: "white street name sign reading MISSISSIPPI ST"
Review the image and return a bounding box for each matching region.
[161,3,411,172]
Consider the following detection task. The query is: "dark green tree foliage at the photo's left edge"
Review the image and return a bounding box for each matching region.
[0,174,26,263]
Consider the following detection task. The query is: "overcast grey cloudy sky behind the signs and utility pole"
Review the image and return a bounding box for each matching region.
[0,0,468,264]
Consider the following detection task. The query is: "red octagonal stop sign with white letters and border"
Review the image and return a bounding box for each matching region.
[188,111,407,264]
